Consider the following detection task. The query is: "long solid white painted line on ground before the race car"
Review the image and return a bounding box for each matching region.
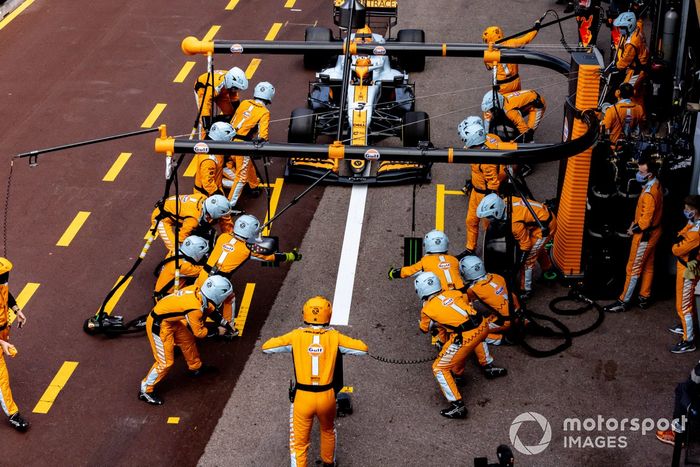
[331,185,367,326]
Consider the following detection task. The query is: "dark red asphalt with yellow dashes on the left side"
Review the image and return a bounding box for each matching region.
[0,0,330,465]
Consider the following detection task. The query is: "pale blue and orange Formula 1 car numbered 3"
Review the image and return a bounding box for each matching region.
[285,27,430,184]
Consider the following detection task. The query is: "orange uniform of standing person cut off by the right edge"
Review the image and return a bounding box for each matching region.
[671,221,700,342]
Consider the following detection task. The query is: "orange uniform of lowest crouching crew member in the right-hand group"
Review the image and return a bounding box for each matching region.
[419,290,488,402]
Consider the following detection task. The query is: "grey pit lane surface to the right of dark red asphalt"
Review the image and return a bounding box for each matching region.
[200,0,696,466]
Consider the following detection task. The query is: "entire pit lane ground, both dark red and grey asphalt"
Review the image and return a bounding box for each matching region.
[0,1,695,466]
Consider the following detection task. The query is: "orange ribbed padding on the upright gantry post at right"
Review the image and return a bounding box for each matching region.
[552,65,600,278]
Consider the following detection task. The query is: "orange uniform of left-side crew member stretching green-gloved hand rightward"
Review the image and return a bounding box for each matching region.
[195,233,275,322]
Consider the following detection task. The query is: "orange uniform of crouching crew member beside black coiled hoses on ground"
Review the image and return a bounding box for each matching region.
[467,273,520,366]
